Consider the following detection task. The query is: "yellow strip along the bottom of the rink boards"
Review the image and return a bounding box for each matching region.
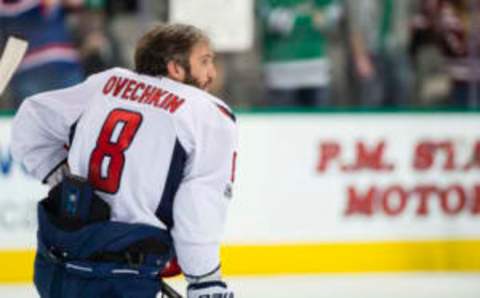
[0,240,480,283]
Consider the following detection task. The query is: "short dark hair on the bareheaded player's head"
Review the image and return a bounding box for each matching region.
[135,24,208,76]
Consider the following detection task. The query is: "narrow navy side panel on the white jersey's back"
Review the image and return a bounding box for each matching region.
[155,139,187,230]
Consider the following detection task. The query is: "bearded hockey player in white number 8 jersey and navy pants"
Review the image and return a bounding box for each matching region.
[12,24,237,298]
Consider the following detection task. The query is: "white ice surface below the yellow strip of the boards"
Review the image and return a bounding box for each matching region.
[0,273,480,298]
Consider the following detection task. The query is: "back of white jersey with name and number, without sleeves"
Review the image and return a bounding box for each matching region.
[68,68,199,228]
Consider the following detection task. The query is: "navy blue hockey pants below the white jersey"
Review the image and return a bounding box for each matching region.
[34,204,173,298]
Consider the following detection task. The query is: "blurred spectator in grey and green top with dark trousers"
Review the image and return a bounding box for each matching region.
[346,0,412,107]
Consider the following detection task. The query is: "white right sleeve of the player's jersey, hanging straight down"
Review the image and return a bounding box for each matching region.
[172,101,237,282]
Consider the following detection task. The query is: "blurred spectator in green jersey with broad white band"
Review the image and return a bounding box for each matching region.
[259,0,342,106]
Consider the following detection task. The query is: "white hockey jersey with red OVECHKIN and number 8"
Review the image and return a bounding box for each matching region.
[12,68,237,276]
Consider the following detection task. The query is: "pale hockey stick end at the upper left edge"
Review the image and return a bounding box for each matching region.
[0,37,28,95]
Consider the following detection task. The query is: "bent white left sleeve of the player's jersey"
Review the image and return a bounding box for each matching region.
[11,74,100,182]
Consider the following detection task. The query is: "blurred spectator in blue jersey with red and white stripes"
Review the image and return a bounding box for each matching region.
[0,0,83,107]
